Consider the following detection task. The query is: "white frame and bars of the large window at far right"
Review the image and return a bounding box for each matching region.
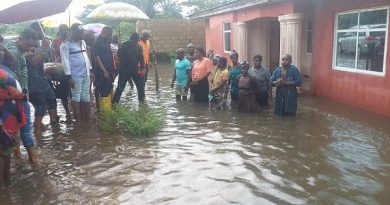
[332,6,390,77]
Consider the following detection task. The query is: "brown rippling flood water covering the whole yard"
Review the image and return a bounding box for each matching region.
[0,63,390,205]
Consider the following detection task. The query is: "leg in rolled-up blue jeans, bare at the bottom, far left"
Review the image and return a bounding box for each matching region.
[20,101,38,163]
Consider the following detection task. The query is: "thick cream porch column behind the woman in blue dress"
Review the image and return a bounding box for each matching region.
[278,13,303,69]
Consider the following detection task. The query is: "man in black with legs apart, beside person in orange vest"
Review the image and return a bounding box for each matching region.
[113,33,145,103]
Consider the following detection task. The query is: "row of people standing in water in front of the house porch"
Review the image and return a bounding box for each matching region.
[171,44,302,116]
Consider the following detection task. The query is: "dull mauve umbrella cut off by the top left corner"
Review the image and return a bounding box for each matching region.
[0,0,72,24]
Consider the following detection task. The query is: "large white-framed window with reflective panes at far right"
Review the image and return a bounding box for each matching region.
[333,8,388,74]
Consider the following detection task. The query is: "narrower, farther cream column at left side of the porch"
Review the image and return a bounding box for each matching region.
[233,22,248,61]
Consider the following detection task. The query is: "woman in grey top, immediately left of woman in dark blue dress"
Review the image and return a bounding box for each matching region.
[248,55,271,106]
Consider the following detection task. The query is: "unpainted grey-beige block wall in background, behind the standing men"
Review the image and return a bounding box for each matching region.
[137,19,205,53]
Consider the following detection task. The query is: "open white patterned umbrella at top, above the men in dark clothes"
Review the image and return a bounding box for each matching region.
[87,2,149,20]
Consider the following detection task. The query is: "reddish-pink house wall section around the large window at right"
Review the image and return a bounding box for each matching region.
[312,0,390,116]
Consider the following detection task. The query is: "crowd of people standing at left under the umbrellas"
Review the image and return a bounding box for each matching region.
[0,22,151,189]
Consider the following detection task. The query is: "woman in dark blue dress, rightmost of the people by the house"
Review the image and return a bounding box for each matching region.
[271,54,302,116]
